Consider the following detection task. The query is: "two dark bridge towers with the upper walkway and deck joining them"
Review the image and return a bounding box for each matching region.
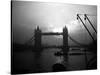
[34,27,68,52]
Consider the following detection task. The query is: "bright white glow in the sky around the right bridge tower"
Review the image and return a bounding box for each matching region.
[49,20,81,39]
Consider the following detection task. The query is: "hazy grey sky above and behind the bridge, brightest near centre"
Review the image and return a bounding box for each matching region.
[12,1,97,45]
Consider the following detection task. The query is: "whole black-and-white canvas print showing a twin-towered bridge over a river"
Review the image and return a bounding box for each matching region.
[11,0,97,74]
